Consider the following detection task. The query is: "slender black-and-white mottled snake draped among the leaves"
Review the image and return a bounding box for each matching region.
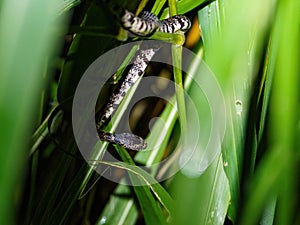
[96,10,191,150]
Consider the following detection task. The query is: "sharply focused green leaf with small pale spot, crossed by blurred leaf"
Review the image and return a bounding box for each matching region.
[198,1,244,221]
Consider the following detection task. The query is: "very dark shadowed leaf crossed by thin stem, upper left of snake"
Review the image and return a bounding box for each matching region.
[57,3,118,104]
